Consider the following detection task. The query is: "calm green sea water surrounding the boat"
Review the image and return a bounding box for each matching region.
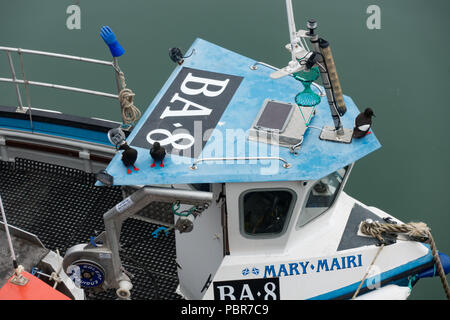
[0,0,450,299]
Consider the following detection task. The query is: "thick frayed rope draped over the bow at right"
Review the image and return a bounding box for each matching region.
[352,219,450,300]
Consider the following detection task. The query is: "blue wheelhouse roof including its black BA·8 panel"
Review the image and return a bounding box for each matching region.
[98,39,381,185]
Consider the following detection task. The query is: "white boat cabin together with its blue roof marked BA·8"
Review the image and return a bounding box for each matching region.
[97,39,380,299]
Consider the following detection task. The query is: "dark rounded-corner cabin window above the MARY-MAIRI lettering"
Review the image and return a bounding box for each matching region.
[240,189,296,237]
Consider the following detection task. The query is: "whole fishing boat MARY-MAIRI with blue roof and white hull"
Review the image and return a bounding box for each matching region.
[0,0,450,300]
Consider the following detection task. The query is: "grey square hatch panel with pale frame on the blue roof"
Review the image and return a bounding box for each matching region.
[255,100,293,132]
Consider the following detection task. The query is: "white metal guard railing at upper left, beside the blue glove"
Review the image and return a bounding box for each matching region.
[0,46,121,118]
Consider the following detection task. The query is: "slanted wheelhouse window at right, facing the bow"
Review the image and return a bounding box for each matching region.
[297,167,348,227]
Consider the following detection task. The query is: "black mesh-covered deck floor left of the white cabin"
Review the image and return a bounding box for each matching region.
[0,158,180,300]
